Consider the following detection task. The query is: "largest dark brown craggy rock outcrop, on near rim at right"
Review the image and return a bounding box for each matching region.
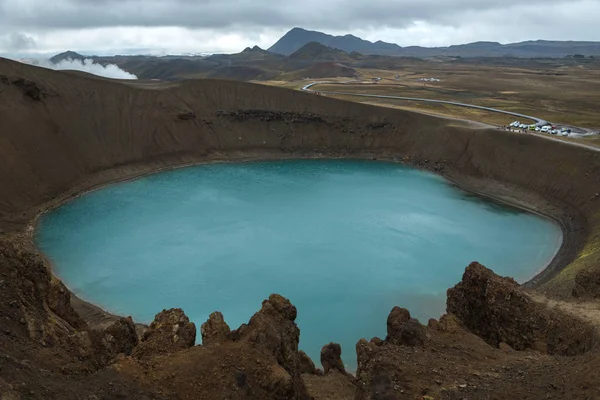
[447,263,599,355]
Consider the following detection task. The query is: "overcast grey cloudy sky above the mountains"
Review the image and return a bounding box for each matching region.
[0,0,600,56]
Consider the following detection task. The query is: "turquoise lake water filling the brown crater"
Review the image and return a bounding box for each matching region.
[36,160,562,369]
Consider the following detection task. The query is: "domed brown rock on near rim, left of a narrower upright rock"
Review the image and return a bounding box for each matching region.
[132,308,196,358]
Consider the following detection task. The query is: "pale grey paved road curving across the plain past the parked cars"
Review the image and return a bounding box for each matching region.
[302,81,600,152]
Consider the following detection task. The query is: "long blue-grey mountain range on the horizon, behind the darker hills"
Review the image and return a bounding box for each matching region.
[269,28,600,58]
